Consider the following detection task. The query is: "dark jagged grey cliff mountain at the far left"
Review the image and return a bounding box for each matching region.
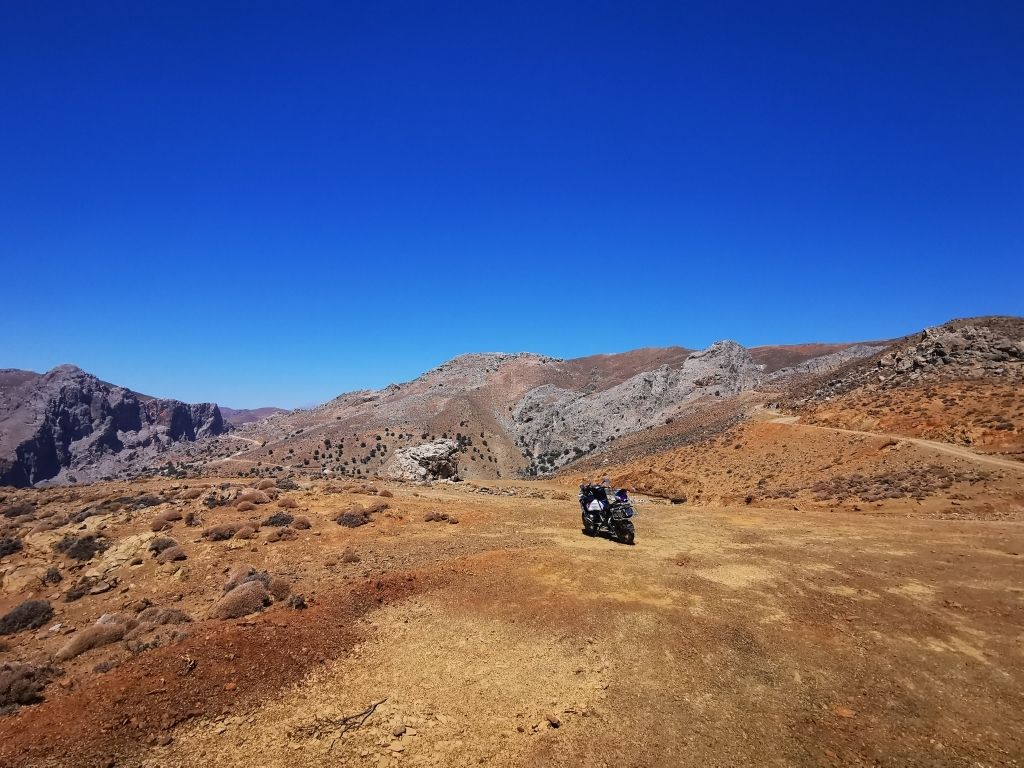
[0,366,225,486]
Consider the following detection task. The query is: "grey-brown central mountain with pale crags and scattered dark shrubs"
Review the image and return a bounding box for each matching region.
[213,341,882,479]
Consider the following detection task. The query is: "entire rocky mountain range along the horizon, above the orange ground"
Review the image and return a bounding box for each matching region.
[14,318,991,485]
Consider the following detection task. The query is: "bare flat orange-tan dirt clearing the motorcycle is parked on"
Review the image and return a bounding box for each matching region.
[0,481,1024,766]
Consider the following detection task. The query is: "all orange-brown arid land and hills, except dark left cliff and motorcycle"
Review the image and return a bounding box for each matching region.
[0,318,1024,767]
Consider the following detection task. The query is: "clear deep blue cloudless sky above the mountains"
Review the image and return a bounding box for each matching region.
[0,0,1024,407]
